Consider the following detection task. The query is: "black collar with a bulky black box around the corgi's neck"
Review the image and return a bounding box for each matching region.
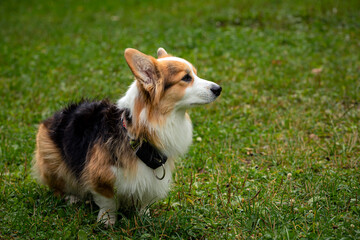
[121,109,167,169]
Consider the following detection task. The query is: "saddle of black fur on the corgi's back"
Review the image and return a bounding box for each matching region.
[44,100,127,177]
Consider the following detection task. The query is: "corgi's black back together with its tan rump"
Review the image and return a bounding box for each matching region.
[34,100,127,195]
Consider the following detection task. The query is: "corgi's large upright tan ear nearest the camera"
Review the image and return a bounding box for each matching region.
[124,48,160,92]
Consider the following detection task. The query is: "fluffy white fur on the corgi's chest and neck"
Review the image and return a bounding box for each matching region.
[112,82,193,207]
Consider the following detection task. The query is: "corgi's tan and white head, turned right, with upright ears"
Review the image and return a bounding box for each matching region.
[125,48,222,113]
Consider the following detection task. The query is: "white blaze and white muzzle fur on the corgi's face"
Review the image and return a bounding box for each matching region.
[158,57,219,107]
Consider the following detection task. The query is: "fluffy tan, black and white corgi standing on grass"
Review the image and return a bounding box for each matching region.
[33,48,222,226]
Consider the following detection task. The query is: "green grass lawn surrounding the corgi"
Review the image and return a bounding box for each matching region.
[0,0,360,239]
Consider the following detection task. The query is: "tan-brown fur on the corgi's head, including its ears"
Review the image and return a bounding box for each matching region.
[125,48,196,129]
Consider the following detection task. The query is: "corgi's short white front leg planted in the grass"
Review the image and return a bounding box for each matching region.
[93,193,119,227]
